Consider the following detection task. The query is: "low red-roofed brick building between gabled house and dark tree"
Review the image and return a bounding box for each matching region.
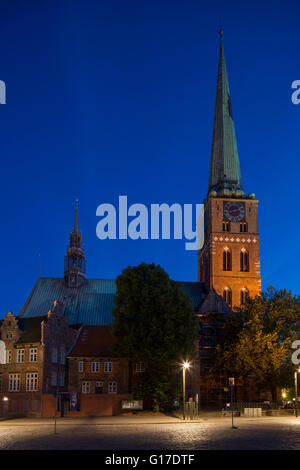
[68,325,132,416]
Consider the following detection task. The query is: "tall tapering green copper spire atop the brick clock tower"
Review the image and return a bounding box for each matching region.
[208,30,244,197]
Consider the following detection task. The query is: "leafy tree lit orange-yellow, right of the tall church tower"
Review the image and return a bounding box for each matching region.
[215,287,300,401]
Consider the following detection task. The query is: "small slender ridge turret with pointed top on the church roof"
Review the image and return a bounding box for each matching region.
[64,201,86,287]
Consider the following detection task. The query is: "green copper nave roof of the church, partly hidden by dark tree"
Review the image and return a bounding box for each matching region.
[19,277,206,325]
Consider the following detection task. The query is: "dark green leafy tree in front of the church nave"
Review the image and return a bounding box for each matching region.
[113,263,196,409]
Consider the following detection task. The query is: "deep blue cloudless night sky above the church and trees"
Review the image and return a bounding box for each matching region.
[0,0,300,317]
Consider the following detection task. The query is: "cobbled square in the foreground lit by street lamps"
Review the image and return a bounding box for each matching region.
[0,415,300,450]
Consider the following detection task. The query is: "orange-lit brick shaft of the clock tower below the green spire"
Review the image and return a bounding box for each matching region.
[198,197,261,308]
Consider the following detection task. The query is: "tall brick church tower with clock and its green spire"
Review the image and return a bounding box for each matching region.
[198,31,261,308]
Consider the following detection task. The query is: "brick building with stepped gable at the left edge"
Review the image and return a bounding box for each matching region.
[0,302,77,416]
